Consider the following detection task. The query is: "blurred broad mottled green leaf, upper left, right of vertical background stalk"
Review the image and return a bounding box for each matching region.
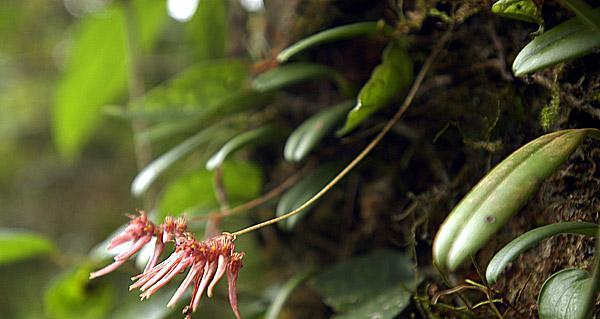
[131,59,248,115]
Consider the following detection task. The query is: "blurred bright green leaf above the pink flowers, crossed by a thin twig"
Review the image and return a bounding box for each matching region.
[159,161,263,218]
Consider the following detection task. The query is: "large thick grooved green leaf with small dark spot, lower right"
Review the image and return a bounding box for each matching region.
[433,129,598,271]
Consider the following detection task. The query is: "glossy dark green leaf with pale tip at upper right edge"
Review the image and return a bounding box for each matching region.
[513,8,600,76]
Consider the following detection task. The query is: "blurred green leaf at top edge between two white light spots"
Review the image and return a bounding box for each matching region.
[186,0,229,61]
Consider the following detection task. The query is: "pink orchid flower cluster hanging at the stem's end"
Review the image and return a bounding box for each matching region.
[90,211,244,319]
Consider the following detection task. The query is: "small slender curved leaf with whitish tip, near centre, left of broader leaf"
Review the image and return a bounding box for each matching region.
[206,125,279,171]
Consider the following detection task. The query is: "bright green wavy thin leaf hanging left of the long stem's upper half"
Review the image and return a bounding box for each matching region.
[338,42,413,135]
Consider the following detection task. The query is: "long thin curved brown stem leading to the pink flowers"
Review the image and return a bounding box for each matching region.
[232,27,452,236]
